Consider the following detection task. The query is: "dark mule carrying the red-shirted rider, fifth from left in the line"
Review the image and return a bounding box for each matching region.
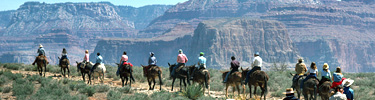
[116,63,132,87]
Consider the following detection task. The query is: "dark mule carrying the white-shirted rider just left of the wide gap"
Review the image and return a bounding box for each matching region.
[241,67,269,100]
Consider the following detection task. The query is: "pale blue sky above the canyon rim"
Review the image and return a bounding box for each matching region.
[0,0,188,11]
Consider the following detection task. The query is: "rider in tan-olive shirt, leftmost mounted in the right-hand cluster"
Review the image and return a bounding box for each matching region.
[293,58,307,87]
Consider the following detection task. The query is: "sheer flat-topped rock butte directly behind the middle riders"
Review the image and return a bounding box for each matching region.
[90,18,298,68]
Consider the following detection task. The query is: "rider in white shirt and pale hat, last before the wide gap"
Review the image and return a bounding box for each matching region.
[245,52,263,84]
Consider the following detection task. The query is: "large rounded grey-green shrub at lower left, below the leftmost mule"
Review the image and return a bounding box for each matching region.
[12,78,34,96]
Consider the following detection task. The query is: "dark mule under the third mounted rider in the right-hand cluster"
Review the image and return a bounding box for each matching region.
[319,81,332,100]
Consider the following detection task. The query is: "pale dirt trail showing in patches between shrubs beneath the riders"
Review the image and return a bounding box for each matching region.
[1,68,281,100]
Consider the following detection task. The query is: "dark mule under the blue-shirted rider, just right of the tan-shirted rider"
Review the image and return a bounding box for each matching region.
[302,78,319,100]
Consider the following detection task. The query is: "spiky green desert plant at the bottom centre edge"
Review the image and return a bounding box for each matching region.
[181,85,204,100]
